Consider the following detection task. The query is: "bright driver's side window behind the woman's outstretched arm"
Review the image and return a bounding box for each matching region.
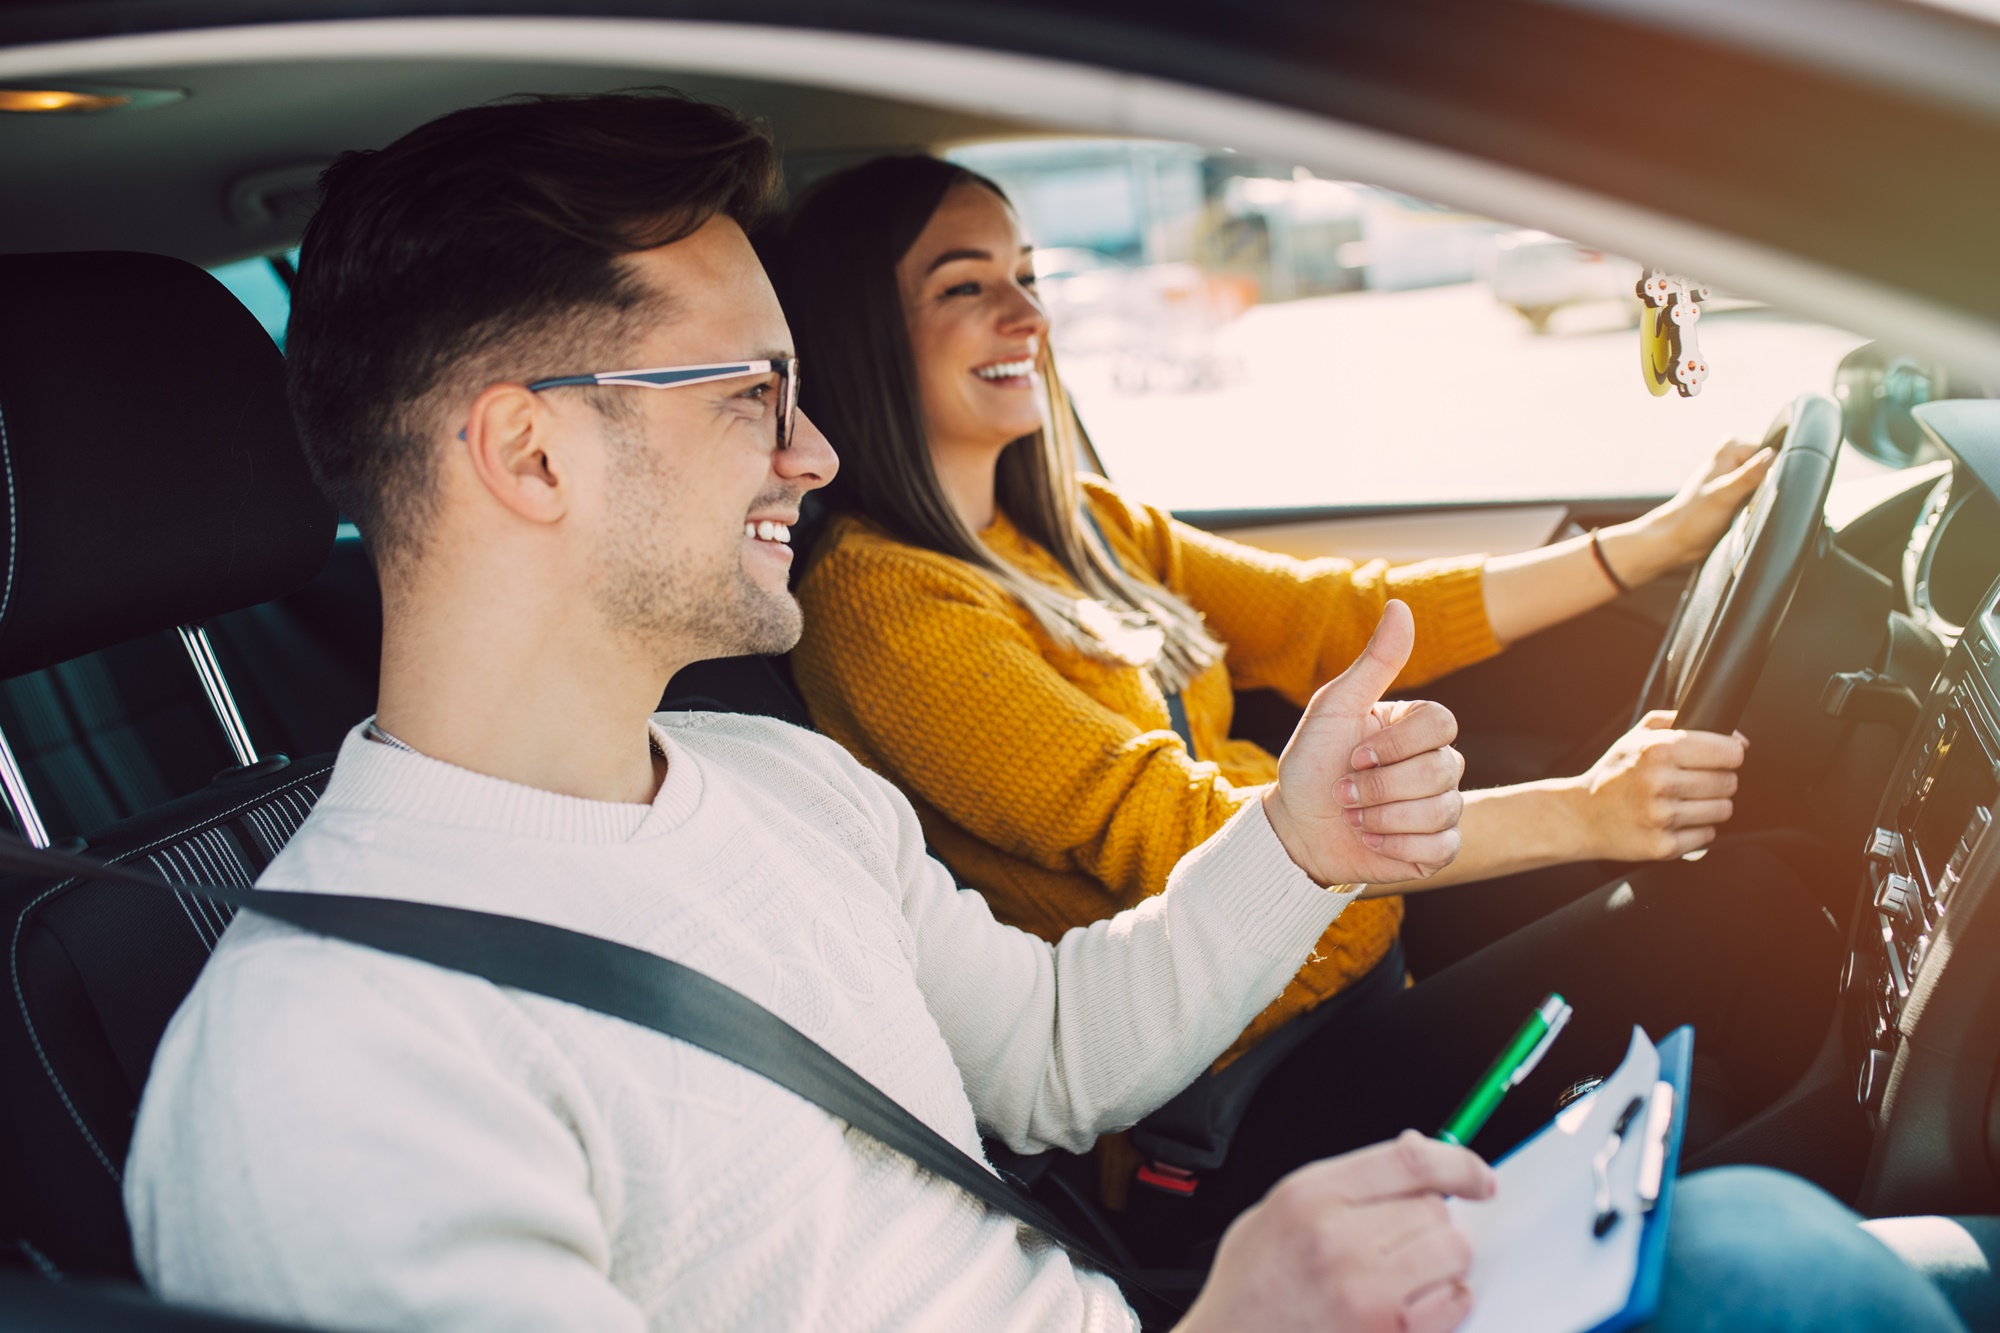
[950,140,1864,510]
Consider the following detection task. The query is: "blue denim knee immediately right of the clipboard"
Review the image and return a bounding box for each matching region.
[1650,1167,1966,1333]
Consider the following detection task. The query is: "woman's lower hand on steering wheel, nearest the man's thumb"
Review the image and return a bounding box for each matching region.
[1570,713,1750,861]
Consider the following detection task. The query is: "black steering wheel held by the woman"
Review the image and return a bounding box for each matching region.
[1664,394,1842,733]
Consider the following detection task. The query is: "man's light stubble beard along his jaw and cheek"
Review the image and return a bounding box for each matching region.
[592,422,804,660]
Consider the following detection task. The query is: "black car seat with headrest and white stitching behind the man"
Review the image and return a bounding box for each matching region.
[0,254,334,1277]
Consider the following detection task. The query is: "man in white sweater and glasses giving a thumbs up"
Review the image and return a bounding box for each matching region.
[126,88,1948,1329]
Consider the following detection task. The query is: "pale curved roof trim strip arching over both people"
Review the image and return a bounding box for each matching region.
[0,16,2000,378]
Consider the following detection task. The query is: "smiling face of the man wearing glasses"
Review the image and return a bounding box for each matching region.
[578,218,838,660]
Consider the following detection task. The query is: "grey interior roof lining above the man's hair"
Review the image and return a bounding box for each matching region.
[0,50,1020,264]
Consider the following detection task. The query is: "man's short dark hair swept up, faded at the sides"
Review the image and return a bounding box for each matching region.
[286,94,778,566]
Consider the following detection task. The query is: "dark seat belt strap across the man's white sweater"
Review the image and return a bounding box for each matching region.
[0,837,1184,1329]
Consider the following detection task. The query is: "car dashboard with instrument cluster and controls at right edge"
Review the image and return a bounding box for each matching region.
[1840,402,2000,1213]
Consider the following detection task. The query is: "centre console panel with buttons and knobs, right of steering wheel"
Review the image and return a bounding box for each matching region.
[1842,594,2000,1121]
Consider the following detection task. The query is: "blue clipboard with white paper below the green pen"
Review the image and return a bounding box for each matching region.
[1446,1027,1694,1333]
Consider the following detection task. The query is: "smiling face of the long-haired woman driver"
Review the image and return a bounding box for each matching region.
[896,184,1048,454]
